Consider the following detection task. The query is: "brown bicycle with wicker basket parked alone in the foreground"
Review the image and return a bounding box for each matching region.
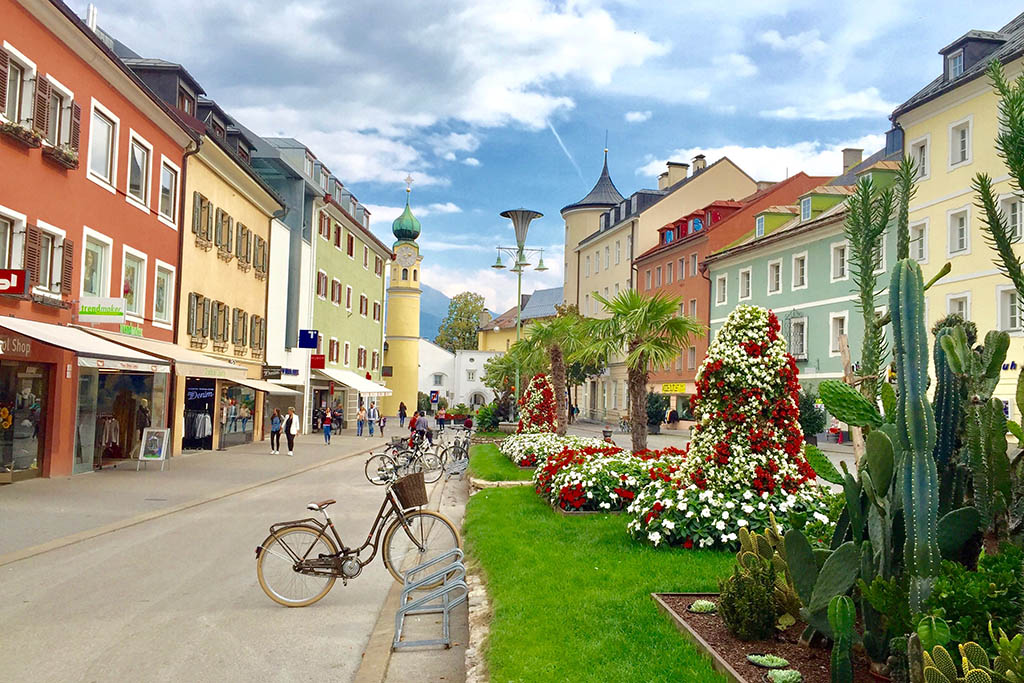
[256,474,462,607]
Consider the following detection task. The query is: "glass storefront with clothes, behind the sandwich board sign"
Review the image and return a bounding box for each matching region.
[74,367,169,474]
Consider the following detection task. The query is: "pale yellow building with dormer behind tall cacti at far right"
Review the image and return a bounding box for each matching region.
[892,14,1024,411]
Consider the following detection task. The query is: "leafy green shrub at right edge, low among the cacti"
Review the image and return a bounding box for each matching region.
[925,544,1024,649]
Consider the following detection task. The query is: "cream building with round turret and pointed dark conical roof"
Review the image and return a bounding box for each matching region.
[562,156,758,421]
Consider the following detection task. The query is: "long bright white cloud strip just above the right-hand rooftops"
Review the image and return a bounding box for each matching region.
[636,135,885,180]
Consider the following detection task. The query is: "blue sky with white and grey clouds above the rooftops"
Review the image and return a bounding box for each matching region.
[70,0,1021,311]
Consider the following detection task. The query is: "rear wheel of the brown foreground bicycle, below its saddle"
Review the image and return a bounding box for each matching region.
[256,526,338,607]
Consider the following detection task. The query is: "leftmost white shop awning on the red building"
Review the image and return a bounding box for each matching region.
[0,317,170,373]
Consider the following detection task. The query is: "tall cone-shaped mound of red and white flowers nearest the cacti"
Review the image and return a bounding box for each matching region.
[628,305,825,548]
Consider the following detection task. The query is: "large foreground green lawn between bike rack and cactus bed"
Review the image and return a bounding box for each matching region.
[465,488,735,683]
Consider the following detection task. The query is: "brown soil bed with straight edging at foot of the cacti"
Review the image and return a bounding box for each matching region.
[652,593,874,683]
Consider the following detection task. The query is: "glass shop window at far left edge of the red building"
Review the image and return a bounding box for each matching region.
[0,360,50,482]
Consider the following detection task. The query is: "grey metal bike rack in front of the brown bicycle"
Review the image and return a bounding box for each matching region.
[391,548,469,650]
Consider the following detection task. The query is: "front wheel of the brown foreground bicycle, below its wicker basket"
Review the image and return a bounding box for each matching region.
[383,510,462,584]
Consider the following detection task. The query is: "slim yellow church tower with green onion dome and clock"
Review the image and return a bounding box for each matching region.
[381,185,423,416]
